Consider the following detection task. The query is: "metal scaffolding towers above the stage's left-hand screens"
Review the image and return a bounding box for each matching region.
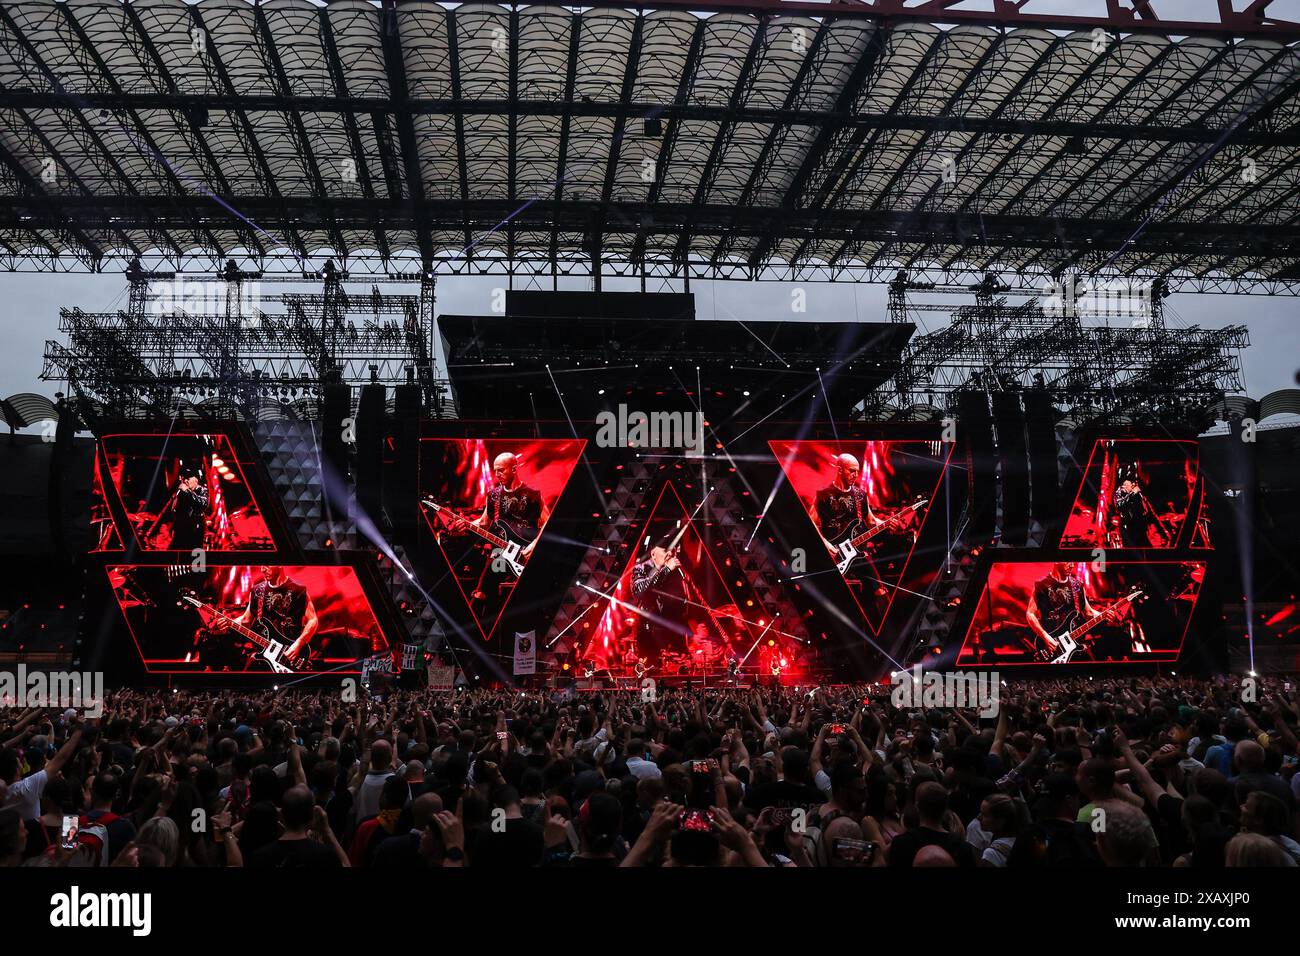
[42,263,455,421]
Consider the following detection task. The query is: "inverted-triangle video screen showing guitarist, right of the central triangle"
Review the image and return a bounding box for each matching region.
[768,440,952,631]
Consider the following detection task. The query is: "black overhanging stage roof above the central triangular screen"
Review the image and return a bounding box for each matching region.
[438,315,917,424]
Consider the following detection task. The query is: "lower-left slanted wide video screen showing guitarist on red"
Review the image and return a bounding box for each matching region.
[108,564,387,675]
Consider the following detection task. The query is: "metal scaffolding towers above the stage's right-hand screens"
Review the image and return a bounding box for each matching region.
[863,267,1249,425]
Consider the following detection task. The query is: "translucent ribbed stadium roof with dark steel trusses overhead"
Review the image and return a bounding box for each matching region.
[0,0,1300,293]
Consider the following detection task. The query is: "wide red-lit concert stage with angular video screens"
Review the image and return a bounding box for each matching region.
[7,380,1258,691]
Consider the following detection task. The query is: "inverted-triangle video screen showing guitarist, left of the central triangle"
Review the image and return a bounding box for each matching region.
[420,438,586,640]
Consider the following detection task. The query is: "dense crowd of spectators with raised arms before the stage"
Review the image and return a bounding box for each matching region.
[0,678,1300,869]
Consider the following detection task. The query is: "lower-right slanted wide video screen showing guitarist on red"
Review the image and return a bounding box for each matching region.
[957,561,1205,667]
